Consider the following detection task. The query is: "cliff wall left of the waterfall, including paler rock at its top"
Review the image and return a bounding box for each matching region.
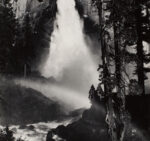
[20,0,57,72]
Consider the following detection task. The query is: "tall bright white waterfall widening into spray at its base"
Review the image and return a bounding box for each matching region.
[42,0,98,92]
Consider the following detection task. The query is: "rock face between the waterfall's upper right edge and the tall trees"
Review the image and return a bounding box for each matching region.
[75,0,100,60]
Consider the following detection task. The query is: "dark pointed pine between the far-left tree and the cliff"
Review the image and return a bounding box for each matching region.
[12,14,35,75]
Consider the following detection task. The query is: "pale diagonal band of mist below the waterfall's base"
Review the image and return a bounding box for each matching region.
[15,79,91,112]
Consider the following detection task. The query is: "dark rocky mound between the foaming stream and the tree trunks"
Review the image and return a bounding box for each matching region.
[47,103,110,141]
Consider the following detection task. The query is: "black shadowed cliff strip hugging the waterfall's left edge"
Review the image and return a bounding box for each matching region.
[31,0,57,69]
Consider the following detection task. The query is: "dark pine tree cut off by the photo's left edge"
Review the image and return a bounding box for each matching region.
[0,0,16,73]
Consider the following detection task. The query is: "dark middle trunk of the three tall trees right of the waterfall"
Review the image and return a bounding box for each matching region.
[112,0,125,141]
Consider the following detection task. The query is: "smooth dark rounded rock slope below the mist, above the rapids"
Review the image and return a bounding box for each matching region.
[0,82,65,125]
